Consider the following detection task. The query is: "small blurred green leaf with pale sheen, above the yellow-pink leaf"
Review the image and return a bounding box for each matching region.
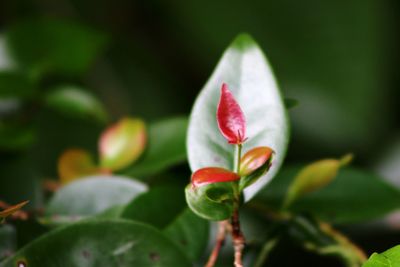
[44,85,108,122]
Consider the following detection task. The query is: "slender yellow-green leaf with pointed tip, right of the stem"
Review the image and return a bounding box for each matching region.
[283,155,352,208]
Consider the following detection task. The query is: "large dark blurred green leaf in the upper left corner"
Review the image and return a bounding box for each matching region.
[5,18,106,75]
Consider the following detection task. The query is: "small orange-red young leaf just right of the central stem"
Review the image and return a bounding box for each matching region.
[239,146,274,176]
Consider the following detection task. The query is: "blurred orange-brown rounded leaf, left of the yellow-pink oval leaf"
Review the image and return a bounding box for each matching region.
[57,149,99,184]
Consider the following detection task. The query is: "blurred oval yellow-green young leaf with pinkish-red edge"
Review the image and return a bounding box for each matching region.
[99,118,147,170]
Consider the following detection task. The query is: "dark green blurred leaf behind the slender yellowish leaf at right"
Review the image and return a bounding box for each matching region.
[256,167,400,223]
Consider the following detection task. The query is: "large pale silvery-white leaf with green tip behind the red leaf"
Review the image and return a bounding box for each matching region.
[187,34,289,200]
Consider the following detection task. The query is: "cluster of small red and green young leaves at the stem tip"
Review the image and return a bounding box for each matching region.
[185,84,274,221]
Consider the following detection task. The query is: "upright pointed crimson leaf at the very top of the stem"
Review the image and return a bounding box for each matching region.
[217,83,246,144]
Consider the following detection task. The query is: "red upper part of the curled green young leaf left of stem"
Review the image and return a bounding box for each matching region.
[192,167,240,187]
